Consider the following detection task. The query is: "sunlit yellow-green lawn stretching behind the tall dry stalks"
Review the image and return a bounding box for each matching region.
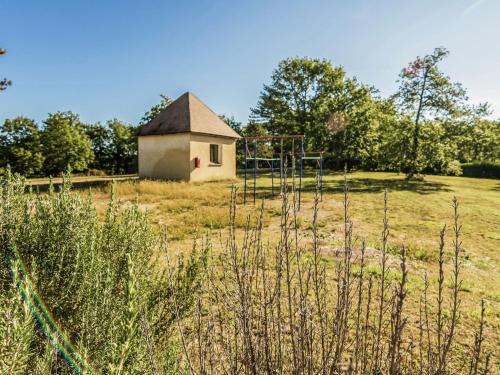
[44,172,500,352]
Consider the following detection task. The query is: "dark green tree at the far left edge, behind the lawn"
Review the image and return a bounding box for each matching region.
[0,116,44,177]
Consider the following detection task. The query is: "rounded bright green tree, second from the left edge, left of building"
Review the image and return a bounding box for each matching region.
[42,111,94,175]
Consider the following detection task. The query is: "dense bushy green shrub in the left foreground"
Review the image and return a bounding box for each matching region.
[0,175,206,374]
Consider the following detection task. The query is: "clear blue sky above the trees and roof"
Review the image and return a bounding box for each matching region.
[0,0,500,123]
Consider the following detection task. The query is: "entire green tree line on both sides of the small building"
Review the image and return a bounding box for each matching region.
[0,48,500,177]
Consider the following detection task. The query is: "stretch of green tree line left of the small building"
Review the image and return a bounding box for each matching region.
[0,111,137,176]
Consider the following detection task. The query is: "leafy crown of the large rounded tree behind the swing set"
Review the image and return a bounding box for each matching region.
[252,58,371,150]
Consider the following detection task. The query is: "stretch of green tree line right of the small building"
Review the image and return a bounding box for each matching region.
[248,48,500,177]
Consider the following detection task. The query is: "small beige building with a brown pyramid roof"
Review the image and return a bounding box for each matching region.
[138,92,240,181]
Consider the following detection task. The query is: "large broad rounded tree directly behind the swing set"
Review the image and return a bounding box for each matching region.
[252,58,379,166]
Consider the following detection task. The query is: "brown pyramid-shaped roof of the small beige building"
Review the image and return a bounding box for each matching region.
[138,92,241,138]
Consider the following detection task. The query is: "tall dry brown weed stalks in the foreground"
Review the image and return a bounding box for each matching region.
[185,175,491,375]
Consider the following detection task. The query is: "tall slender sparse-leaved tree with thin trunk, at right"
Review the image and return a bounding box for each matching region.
[395,47,472,178]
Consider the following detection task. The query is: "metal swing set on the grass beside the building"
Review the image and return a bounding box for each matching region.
[243,135,323,210]
